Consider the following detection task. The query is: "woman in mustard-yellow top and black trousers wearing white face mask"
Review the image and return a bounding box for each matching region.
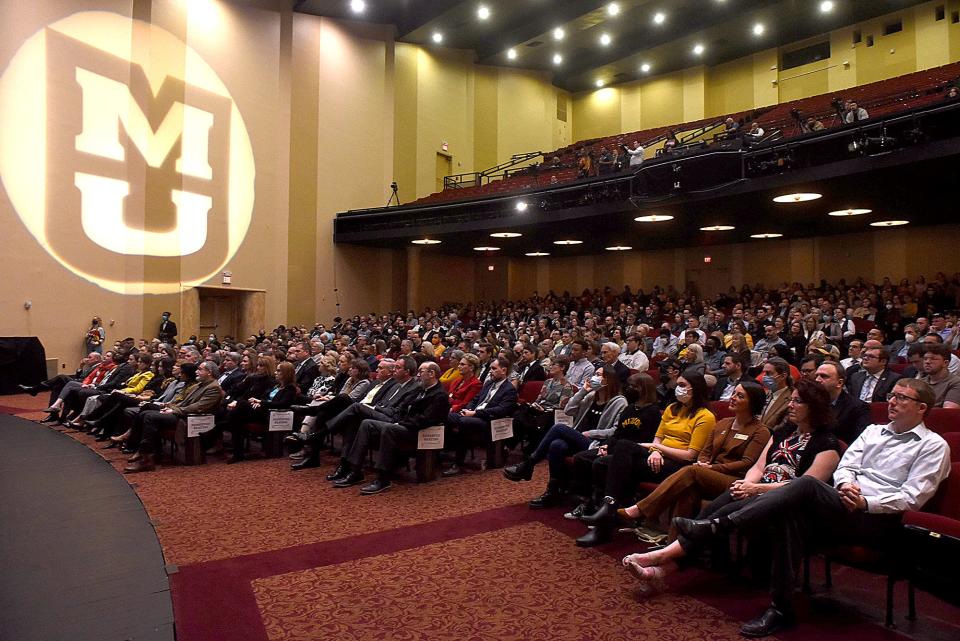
[577,370,717,547]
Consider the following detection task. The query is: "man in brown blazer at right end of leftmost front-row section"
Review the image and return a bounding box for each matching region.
[123,361,223,474]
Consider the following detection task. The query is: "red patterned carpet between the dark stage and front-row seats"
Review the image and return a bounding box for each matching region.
[0,396,960,641]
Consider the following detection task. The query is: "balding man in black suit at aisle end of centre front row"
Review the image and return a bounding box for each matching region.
[330,361,450,495]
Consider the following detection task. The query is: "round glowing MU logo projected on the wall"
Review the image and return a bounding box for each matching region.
[0,12,254,294]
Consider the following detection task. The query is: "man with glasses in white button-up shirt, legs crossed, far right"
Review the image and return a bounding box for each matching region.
[673,378,950,637]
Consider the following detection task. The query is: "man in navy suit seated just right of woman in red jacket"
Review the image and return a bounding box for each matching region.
[443,356,517,476]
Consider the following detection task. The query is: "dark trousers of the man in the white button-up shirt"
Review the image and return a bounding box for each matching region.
[679,476,902,609]
